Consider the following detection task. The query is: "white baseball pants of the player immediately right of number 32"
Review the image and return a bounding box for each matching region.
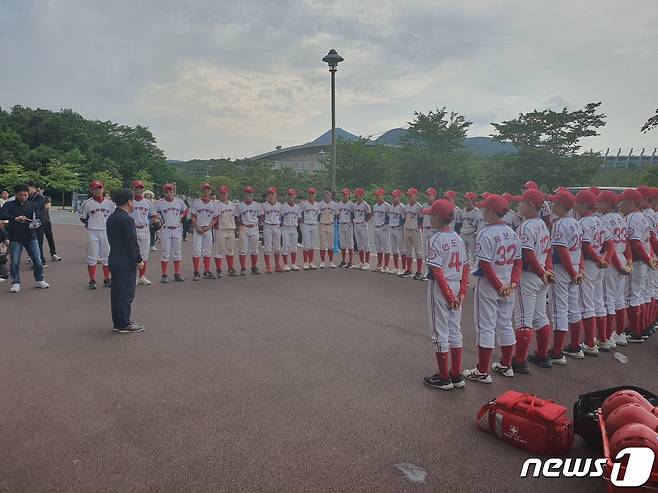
[514,270,549,330]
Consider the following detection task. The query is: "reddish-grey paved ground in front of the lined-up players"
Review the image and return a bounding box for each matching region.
[0,221,658,493]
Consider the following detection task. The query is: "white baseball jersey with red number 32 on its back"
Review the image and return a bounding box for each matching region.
[475,223,521,284]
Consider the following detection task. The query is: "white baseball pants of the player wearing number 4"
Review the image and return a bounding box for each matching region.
[427,280,463,353]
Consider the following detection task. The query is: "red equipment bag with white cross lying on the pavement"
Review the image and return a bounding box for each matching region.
[476,390,573,456]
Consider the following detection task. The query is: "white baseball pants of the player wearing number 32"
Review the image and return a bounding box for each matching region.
[474,277,516,348]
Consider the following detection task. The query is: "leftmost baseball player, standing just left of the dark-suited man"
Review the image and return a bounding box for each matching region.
[78,180,115,289]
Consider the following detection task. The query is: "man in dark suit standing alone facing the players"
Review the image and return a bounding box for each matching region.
[106,189,144,334]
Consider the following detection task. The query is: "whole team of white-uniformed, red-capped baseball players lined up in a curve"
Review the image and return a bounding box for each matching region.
[5,181,658,390]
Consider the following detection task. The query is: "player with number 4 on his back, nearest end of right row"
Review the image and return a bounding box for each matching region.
[423,199,469,390]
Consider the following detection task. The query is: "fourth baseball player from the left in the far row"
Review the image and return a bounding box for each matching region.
[190,183,219,281]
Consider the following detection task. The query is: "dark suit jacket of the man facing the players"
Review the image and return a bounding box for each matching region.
[107,207,142,269]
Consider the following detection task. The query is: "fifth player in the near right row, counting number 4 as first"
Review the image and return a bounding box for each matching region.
[575,190,613,356]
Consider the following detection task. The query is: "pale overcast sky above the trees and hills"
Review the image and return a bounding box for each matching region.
[0,0,658,159]
